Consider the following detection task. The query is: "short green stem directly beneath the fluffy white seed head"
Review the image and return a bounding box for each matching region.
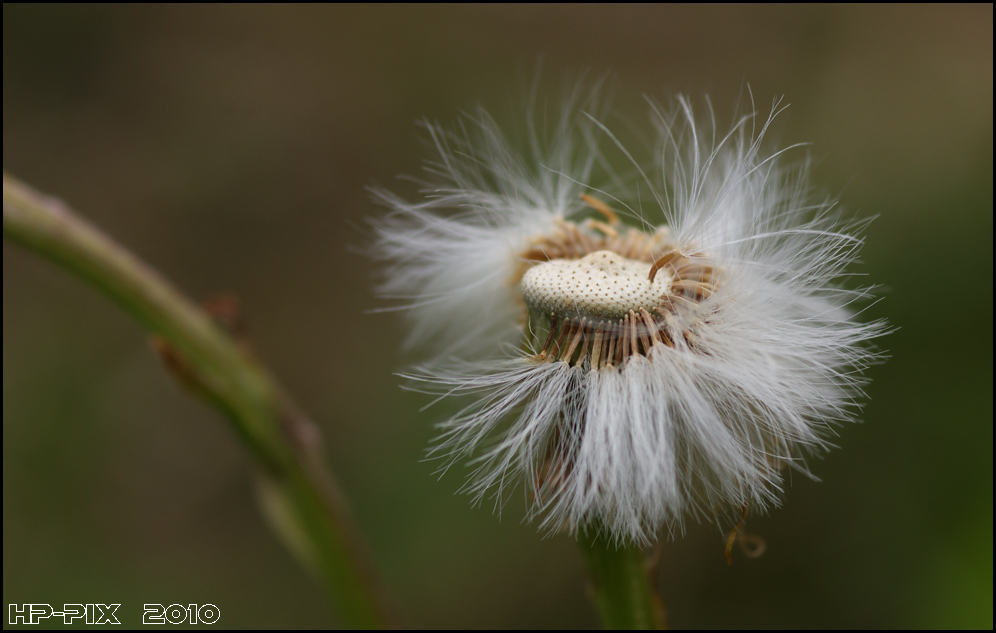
[578,529,665,630]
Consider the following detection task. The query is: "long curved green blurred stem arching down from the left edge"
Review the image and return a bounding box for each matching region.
[3,173,393,628]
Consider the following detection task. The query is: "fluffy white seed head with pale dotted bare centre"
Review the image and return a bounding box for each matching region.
[374,90,887,543]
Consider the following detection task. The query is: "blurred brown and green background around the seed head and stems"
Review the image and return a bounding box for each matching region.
[3,4,993,628]
